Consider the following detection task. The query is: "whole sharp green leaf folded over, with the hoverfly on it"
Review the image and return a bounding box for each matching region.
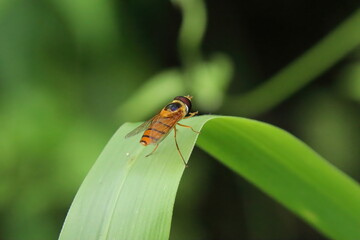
[60,116,360,240]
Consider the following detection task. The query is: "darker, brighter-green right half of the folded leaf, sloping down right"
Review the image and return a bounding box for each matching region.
[198,117,360,240]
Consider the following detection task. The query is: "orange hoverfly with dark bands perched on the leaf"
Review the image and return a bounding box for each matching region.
[125,96,199,166]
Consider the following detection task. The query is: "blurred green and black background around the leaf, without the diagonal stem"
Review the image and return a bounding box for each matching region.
[0,0,360,240]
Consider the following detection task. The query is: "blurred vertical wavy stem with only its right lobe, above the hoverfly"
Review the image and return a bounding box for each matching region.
[173,0,234,112]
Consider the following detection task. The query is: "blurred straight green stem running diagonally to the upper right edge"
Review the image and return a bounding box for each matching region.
[224,9,360,116]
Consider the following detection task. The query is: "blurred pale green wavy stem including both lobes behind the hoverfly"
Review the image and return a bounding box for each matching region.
[118,0,234,117]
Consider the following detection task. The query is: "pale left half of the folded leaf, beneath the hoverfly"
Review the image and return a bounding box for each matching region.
[59,117,215,240]
